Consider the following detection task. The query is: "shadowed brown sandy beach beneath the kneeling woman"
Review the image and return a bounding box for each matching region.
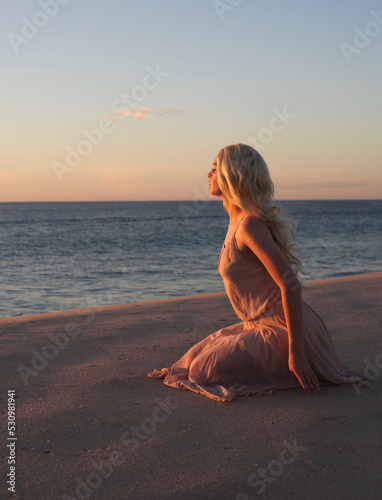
[0,272,382,500]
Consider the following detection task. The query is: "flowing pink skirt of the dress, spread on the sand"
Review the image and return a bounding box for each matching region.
[147,301,364,401]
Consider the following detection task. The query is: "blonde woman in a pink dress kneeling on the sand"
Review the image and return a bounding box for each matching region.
[148,144,361,401]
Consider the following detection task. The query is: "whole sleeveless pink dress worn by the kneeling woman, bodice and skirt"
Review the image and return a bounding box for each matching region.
[147,215,362,401]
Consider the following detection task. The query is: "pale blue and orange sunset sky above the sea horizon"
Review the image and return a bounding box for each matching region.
[0,0,382,202]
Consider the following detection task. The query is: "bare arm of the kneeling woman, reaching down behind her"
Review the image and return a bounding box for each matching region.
[236,217,318,394]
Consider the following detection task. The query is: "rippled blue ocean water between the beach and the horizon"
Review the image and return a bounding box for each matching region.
[0,200,382,318]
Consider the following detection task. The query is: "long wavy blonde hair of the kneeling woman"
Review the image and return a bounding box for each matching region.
[216,144,306,275]
